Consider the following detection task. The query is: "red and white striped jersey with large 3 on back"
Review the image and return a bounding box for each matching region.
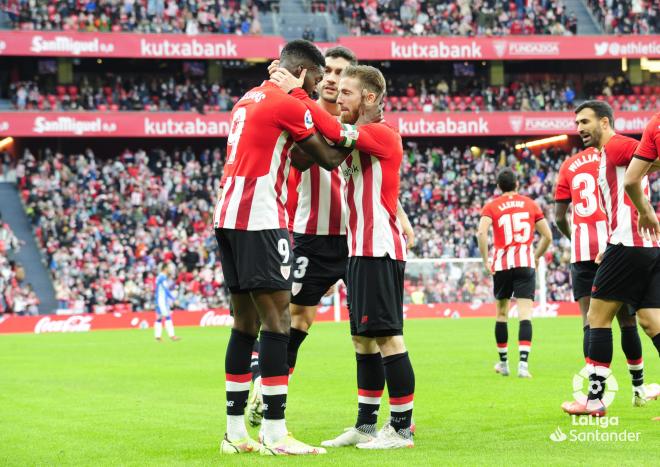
[555,147,609,263]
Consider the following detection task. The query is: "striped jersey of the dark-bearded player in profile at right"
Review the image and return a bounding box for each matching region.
[598,135,660,247]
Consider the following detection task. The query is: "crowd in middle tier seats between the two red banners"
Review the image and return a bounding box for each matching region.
[9,75,660,112]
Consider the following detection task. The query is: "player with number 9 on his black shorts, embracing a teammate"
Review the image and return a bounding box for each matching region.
[214,40,354,455]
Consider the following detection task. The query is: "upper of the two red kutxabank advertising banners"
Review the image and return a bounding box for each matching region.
[0,31,660,60]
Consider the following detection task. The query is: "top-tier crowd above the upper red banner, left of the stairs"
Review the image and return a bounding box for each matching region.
[2,0,268,35]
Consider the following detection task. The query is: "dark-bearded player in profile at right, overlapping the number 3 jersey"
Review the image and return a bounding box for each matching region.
[562,101,660,416]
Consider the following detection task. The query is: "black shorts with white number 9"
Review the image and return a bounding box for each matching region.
[215,229,293,293]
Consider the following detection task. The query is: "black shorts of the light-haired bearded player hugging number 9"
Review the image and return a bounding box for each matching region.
[346,256,406,337]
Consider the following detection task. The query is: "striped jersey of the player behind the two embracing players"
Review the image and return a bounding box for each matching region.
[290,164,346,235]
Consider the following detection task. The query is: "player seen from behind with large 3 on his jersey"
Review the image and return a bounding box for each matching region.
[555,146,660,407]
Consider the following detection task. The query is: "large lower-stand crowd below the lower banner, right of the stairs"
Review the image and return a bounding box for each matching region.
[11,142,660,310]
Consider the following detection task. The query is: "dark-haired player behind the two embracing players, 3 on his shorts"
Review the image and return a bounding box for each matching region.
[258,46,414,428]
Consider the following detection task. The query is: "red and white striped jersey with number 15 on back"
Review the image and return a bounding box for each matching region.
[481,193,545,272]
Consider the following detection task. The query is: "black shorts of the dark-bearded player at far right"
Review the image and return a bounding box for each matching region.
[591,244,660,312]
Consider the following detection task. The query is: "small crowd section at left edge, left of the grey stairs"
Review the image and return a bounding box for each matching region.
[0,218,39,315]
